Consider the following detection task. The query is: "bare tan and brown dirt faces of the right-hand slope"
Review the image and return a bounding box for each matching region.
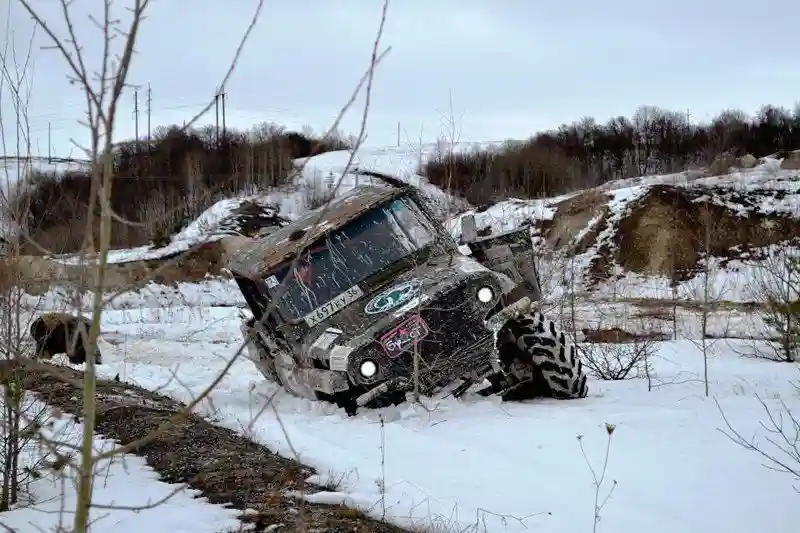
[535,184,800,281]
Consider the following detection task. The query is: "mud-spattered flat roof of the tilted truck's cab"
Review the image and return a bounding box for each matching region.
[228,184,408,278]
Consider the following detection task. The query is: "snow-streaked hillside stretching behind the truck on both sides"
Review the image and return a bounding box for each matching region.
[6,144,800,301]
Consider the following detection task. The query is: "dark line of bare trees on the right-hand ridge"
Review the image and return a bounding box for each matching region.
[420,105,800,204]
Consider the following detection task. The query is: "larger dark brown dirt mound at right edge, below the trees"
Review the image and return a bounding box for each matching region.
[608,185,800,280]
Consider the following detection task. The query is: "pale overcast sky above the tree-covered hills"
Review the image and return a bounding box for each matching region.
[0,0,800,156]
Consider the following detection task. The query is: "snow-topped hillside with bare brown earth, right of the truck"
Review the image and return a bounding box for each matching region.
[449,157,800,300]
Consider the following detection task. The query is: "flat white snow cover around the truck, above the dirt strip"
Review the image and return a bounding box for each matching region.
[20,287,800,533]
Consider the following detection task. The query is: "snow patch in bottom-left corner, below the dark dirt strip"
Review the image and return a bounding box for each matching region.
[0,394,241,533]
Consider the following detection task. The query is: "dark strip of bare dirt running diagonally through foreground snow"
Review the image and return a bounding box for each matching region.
[18,364,404,533]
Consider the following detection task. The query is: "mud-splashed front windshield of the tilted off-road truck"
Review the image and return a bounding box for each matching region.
[265,197,436,320]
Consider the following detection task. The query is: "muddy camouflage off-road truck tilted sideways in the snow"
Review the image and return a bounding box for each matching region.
[228,177,587,414]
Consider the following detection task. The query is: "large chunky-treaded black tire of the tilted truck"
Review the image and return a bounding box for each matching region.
[497,314,589,400]
